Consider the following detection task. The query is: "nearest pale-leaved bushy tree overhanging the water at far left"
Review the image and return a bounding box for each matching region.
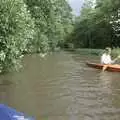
[0,0,34,72]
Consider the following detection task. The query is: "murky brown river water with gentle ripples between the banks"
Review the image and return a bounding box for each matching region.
[0,52,120,120]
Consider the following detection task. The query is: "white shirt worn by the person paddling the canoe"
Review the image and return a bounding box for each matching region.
[101,53,114,64]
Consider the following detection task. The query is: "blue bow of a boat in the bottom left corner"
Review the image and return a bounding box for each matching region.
[0,104,35,120]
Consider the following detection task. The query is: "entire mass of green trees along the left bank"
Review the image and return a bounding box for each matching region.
[0,0,73,72]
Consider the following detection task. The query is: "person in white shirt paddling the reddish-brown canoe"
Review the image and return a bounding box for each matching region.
[101,47,120,71]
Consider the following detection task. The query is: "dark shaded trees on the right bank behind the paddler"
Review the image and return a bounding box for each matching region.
[69,0,120,48]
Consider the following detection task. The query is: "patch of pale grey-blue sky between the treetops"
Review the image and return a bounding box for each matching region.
[68,0,84,16]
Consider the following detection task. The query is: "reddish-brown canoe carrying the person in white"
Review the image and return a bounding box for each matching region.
[86,62,120,72]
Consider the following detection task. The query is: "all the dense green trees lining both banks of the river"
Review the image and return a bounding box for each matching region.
[0,0,120,72]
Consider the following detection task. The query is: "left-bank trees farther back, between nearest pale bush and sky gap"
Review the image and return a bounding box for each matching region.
[25,0,72,52]
